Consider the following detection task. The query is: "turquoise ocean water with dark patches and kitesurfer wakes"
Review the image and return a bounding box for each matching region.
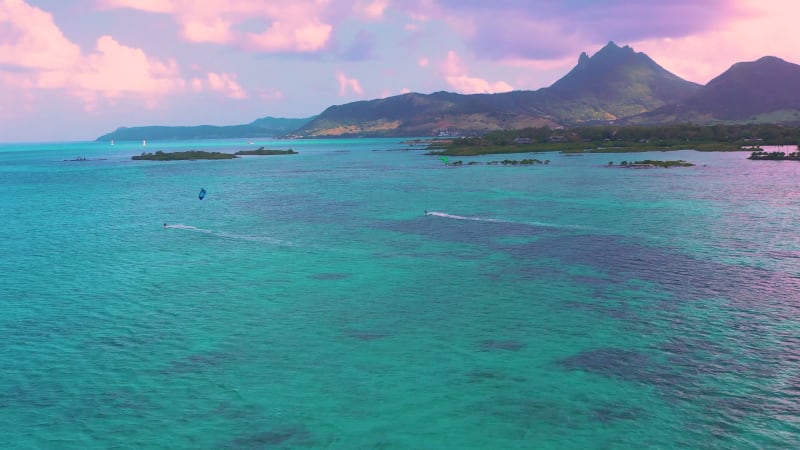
[0,139,800,449]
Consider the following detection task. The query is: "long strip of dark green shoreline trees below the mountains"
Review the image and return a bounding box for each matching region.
[428,124,800,156]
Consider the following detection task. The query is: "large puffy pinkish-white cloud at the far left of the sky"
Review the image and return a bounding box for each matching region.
[0,0,246,111]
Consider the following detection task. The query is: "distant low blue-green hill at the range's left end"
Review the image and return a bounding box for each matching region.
[96,117,312,142]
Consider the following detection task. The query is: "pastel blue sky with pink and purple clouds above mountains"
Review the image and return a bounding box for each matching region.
[0,0,800,142]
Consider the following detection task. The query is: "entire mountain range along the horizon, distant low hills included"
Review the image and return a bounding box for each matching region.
[98,42,800,140]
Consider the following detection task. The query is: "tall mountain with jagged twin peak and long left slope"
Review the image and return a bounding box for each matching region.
[297,42,701,136]
